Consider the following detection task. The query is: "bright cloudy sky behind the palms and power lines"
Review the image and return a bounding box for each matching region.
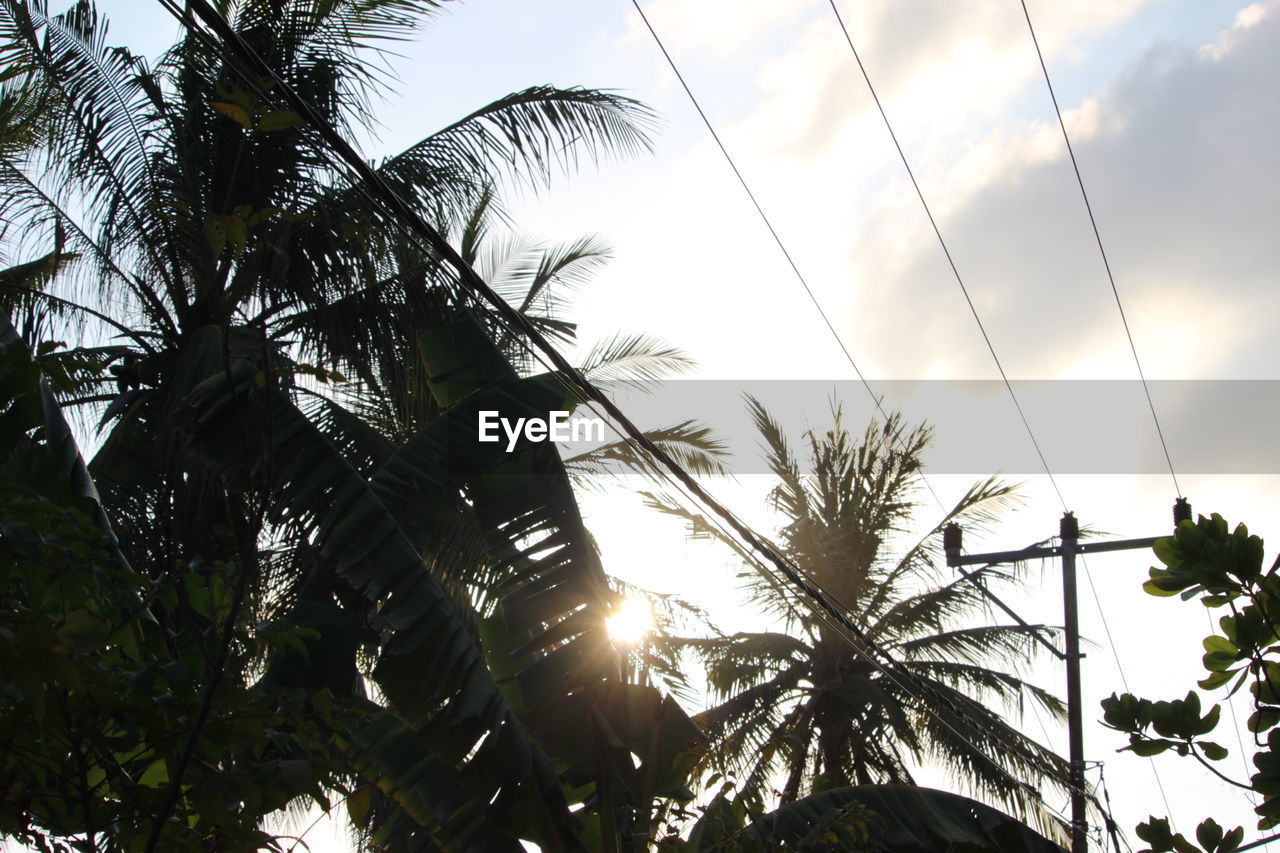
[37,0,1280,850]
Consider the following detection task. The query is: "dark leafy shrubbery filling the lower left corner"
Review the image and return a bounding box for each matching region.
[0,315,358,850]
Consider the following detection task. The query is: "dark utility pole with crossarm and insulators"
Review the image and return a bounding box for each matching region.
[942,498,1192,853]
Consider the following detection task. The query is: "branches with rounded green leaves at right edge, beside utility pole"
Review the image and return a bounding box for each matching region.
[1102,514,1280,853]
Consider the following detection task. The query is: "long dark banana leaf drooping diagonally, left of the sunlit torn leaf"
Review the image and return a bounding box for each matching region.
[183,361,581,850]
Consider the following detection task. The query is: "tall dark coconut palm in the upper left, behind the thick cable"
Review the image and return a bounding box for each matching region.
[0,0,649,565]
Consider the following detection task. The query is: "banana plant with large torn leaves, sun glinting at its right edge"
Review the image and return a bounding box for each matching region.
[183,312,700,850]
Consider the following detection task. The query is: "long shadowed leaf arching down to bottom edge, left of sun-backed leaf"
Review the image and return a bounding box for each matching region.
[180,362,572,848]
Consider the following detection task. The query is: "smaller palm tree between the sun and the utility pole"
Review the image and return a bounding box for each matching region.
[650,400,1066,820]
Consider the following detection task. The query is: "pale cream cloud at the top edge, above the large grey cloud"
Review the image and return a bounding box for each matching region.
[755,0,1148,166]
